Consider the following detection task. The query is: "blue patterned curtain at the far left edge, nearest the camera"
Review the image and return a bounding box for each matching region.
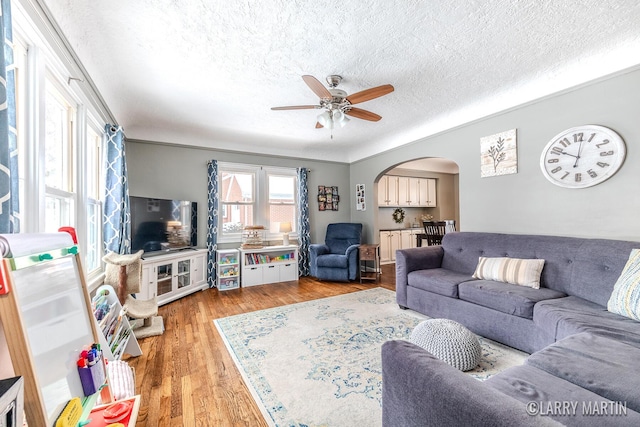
[0,0,20,233]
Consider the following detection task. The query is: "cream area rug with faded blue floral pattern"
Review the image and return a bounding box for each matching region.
[214,288,527,426]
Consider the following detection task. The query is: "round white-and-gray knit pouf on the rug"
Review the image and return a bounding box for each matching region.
[411,319,482,371]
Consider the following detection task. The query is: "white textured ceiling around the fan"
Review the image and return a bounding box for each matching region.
[44,0,640,162]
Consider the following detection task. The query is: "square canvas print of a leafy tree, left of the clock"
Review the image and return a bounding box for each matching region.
[480,129,518,178]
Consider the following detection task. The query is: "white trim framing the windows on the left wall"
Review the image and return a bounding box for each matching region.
[11,0,111,291]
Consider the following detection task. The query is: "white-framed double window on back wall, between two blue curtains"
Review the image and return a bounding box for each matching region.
[218,163,297,242]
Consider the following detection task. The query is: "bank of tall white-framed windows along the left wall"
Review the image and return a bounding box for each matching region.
[12,8,115,287]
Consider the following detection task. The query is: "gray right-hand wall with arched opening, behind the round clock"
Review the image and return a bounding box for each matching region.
[351,69,640,246]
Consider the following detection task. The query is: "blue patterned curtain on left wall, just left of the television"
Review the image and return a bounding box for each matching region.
[102,124,131,254]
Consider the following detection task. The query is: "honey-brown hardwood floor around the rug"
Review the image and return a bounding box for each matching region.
[127,264,395,427]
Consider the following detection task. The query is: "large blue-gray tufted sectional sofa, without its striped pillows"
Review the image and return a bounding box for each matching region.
[382,232,640,426]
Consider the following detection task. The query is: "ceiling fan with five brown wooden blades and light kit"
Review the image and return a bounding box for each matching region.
[271,74,393,138]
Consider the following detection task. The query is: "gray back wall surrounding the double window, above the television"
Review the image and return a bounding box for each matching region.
[126,140,355,247]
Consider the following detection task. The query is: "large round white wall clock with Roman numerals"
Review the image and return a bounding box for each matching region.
[540,125,627,188]
